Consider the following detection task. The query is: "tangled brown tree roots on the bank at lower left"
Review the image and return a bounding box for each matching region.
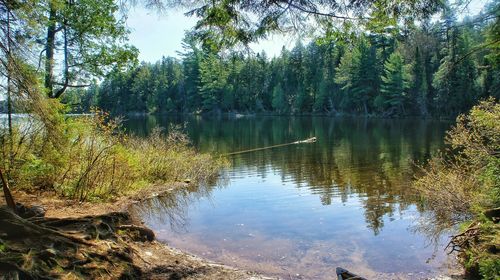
[0,207,145,279]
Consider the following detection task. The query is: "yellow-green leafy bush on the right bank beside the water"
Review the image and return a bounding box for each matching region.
[415,99,500,279]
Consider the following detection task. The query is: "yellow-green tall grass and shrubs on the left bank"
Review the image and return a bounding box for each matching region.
[0,111,226,201]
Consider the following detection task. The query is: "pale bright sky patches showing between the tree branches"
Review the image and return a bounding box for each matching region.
[127,0,487,62]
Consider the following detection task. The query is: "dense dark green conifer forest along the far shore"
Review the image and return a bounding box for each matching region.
[63,3,500,117]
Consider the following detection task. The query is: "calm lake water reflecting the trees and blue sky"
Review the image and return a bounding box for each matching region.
[126,117,458,279]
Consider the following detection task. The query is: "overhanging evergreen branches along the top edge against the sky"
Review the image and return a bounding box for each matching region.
[172,0,442,51]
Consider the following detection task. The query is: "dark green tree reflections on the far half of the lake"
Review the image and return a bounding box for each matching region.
[124,117,448,234]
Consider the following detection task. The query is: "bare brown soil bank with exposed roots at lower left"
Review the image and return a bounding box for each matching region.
[0,184,274,280]
